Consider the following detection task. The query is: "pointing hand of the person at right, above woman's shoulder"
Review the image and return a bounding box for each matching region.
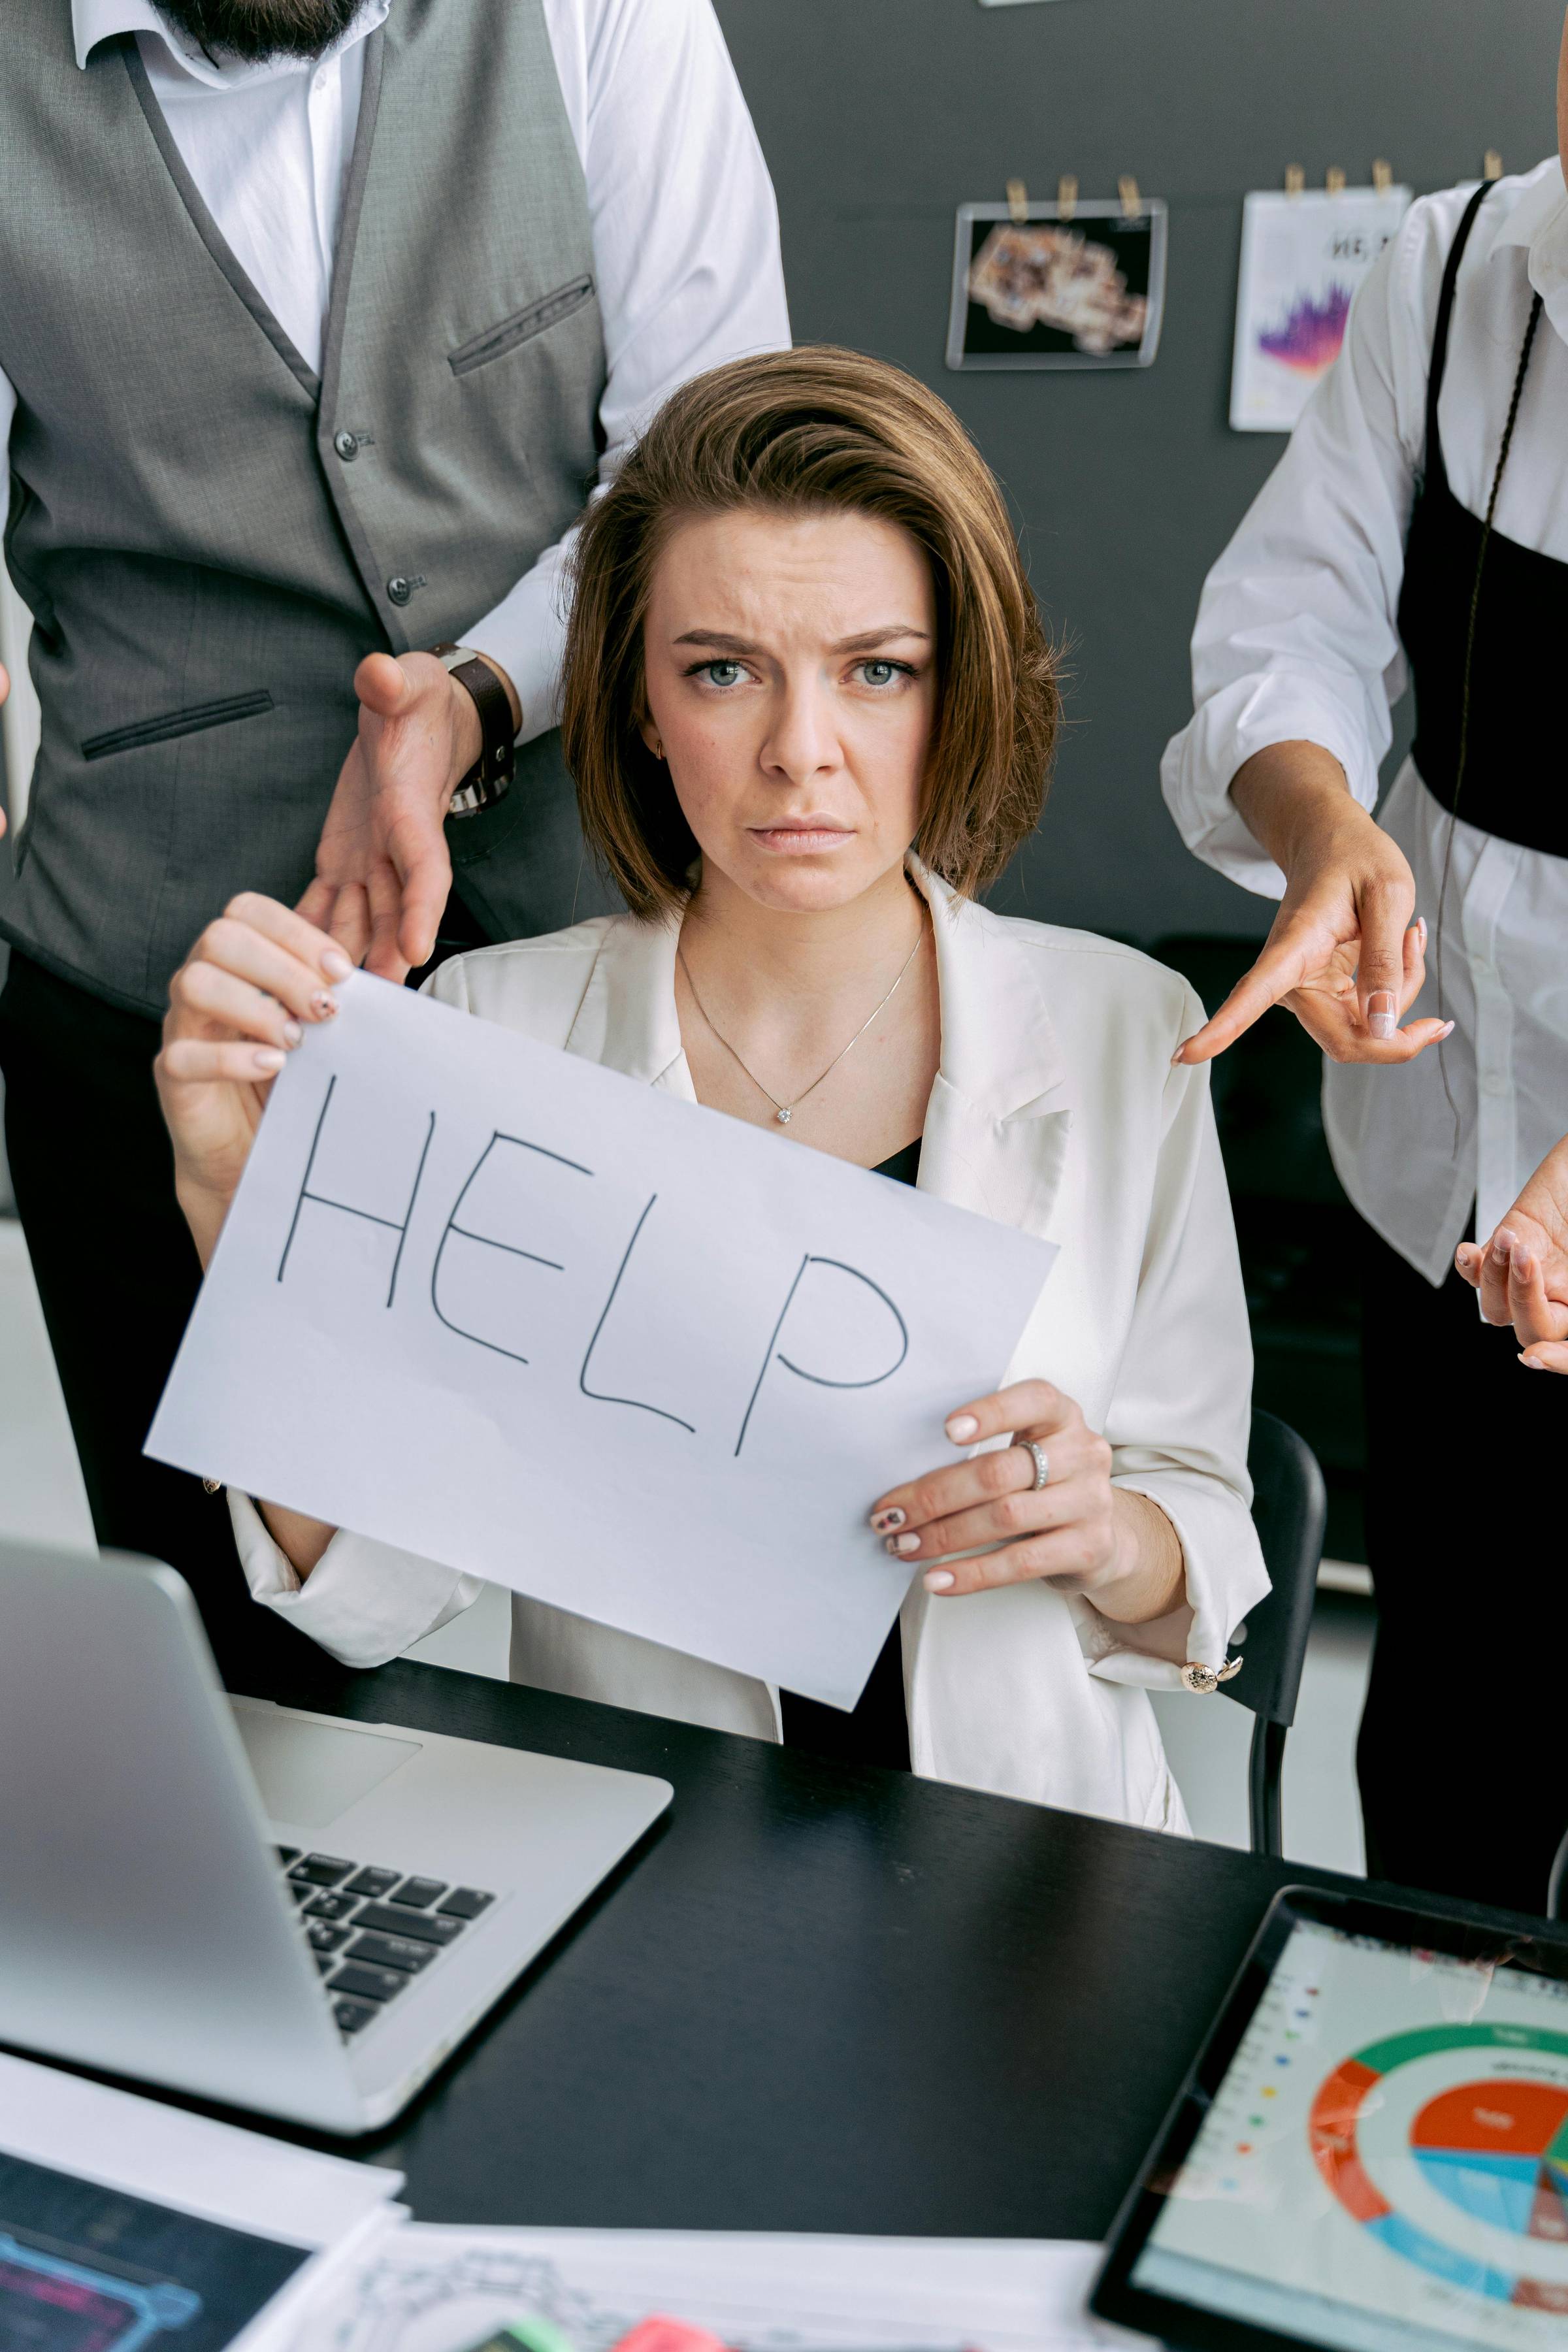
[1175,743,1453,1063]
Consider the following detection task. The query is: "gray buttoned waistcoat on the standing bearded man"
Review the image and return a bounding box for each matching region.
[0,0,604,1011]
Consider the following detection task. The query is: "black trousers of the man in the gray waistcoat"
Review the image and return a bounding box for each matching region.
[0,955,333,1689]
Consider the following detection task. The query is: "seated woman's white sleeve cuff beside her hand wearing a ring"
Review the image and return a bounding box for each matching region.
[1070,1470,1269,1691]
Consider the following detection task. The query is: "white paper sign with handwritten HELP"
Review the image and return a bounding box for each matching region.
[148,976,1056,1705]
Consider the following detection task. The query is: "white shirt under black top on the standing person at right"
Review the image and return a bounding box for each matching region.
[1162,157,1568,1282]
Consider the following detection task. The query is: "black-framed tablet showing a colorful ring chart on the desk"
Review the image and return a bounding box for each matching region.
[1098,1896,1568,2352]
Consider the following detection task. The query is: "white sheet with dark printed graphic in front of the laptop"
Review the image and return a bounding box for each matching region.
[0,2055,404,2352]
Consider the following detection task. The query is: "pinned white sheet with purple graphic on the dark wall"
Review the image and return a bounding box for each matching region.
[1230,186,1411,433]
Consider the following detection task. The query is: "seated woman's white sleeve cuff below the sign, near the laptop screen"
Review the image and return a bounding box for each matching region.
[228,1486,484,1665]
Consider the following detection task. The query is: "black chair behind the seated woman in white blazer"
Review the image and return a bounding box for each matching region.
[1220,1414,1328,1861]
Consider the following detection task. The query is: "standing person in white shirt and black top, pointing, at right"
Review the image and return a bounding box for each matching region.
[1164,14,1568,1910]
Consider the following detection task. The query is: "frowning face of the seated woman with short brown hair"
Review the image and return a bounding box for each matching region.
[644,508,936,913]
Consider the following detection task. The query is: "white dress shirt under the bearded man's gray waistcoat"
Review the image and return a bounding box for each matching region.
[0,0,790,750]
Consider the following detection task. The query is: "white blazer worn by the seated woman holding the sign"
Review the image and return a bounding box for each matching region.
[231,868,1267,1830]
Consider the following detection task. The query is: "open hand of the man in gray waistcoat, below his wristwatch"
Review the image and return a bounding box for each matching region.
[299,654,519,981]
